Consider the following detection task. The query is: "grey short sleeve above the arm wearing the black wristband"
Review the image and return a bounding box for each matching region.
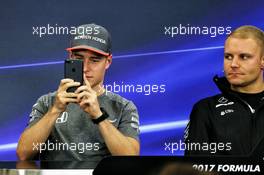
[118,101,140,141]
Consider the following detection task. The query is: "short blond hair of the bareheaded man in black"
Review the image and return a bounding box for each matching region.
[227,25,264,55]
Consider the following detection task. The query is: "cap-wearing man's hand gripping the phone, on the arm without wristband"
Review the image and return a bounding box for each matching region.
[53,78,80,112]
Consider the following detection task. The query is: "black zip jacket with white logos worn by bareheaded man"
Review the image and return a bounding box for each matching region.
[185,76,264,155]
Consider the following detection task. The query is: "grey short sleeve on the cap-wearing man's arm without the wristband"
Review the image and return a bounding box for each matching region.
[27,95,49,128]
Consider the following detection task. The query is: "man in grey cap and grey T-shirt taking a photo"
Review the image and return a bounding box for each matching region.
[17,24,140,161]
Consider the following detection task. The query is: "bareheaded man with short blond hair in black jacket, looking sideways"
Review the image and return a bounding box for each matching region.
[185,26,264,155]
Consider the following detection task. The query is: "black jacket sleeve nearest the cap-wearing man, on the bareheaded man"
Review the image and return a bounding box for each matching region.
[184,101,211,155]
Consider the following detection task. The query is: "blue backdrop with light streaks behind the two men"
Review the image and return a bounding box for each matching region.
[0,0,264,160]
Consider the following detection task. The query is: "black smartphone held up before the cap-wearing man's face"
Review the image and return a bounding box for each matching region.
[64,59,83,92]
